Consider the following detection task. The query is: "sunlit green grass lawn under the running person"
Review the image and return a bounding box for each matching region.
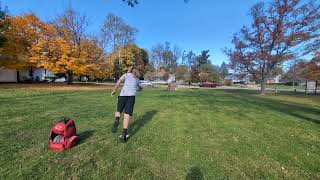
[0,89,320,179]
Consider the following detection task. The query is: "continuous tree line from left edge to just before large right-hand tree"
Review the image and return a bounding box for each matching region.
[0,3,230,84]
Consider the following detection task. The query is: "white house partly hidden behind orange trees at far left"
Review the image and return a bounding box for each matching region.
[0,68,55,82]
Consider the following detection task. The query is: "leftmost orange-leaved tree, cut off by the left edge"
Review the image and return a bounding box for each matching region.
[0,14,46,81]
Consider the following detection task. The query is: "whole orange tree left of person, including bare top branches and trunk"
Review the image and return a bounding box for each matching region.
[30,8,111,84]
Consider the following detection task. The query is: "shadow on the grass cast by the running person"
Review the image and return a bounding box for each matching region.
[129,110,158,137]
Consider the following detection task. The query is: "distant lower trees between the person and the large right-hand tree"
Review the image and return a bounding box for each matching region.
[147,42,228,83]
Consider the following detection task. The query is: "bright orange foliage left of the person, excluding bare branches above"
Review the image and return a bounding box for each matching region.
[30,25,110,81]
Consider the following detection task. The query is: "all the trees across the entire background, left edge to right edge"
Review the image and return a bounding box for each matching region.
[0,0,320,91]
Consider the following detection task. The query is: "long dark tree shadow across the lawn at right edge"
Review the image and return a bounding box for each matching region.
[220,90,320,124]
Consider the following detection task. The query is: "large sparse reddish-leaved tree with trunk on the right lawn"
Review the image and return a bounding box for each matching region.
[226,0,320,94]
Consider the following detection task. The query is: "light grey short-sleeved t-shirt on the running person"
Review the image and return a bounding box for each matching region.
[120,73,140,96]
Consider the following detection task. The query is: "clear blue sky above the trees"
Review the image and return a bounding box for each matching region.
[2,0,257,65]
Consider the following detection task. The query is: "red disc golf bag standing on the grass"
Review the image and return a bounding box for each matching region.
[49,118,78,151]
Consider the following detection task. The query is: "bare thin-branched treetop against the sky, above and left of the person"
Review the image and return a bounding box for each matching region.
[101,13,138,51]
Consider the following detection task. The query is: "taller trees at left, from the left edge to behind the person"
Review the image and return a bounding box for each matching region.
[0,7,148,84]
